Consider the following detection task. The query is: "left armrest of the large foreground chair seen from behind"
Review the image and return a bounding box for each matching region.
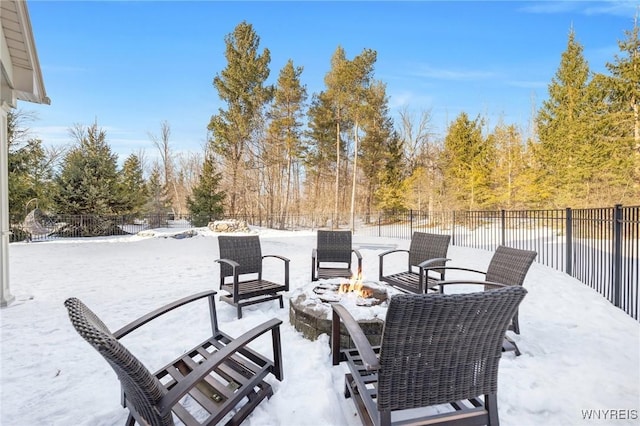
[331,303,380,371]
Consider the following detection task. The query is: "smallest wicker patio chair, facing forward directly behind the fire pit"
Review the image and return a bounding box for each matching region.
[311,230,362,281]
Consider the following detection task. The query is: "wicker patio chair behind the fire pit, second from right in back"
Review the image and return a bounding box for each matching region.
[379,232,451,293]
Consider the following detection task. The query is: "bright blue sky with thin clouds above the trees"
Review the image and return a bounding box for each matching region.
[20,0,640,161]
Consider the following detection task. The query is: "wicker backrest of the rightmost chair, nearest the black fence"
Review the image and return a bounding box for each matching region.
[485,246,538,286]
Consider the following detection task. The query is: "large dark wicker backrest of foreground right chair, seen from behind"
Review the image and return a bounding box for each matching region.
[377,286,527,411]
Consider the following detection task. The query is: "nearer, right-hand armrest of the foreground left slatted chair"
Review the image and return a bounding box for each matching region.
[158,318,282,415]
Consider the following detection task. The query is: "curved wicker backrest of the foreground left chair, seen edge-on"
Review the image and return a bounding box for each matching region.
[64,297,174,426]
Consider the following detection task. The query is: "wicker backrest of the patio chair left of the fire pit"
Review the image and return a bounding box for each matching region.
[218,235,262,278]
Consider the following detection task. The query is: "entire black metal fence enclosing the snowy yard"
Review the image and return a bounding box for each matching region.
[12,205,640,319]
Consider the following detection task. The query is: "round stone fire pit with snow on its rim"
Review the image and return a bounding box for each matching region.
[289,278,400,347]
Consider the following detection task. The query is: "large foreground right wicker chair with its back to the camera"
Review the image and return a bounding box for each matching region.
[331,285,526,425]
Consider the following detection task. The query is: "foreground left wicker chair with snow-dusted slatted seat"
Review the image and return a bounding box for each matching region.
[64,291,283,426]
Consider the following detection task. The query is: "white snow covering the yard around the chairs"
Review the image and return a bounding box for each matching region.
[0,228,640,426]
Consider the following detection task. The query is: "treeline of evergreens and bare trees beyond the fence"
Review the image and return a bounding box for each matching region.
[8,20,640,226]
